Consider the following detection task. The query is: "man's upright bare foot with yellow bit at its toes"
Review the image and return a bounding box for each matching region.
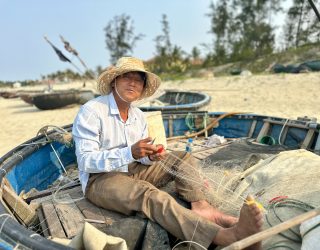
[213,196,263,250]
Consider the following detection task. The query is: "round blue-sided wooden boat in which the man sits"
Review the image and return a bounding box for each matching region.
[0,112,320,249]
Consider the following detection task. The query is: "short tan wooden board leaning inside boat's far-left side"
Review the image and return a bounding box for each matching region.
[2,184,36,226]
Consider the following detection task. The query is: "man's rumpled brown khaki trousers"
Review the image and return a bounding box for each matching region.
[86,152,219,248]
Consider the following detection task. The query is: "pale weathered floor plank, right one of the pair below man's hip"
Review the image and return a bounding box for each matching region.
[54,194,84,239]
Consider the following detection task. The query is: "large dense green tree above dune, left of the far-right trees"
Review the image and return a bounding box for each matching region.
[206,0,281,64]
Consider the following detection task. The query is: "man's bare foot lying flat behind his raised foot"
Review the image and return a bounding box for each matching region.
[191,200,238,228]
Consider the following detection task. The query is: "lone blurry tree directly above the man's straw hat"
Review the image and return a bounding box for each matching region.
[104,14,144,64]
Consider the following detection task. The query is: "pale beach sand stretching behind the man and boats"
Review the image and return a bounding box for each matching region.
[0,73,320,156]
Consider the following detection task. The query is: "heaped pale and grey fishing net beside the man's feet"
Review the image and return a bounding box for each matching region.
[194,146,320,249]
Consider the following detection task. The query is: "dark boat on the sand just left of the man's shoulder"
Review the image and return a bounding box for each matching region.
[32,90,94,110]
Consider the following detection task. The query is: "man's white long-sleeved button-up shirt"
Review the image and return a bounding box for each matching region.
[72,93,152,193]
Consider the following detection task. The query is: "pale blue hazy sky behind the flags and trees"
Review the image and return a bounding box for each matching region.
[0,0,290,81]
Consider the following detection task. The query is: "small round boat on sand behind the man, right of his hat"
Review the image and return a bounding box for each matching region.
[139,90,211,113]
